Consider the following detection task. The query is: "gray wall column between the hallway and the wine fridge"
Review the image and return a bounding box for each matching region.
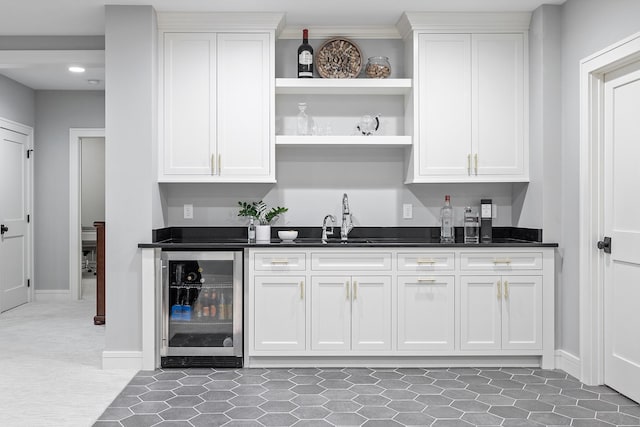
[105,5,158,352]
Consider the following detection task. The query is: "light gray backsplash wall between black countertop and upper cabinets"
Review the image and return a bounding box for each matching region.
[164,147,512,227]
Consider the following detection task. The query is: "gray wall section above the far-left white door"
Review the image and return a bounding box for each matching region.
[0,75,36,127]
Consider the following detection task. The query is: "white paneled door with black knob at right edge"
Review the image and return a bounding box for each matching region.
[603,61,640,402]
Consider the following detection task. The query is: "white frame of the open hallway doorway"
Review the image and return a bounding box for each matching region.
[69,128,106,300]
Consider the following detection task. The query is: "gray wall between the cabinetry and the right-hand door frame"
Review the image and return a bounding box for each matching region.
[549,0,640,355]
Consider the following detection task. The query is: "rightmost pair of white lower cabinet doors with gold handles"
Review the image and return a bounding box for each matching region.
[460,275,542,350]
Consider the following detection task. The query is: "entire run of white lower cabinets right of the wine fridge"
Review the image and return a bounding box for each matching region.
[246,246,555,369]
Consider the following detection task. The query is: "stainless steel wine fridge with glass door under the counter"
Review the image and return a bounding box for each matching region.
[159,251,243,368]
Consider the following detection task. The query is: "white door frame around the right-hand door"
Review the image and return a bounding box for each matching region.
[578,33,640,385]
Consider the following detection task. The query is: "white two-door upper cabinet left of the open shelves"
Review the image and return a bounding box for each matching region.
[158,14,279,182]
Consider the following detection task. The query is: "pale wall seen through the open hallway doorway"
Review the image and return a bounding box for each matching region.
[80,138,104,227]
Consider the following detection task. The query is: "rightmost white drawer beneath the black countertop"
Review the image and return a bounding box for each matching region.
[460,252,542,271]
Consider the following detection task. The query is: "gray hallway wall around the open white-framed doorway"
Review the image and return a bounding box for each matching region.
[34,91,105,290]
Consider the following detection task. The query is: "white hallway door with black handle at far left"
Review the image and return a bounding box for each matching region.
[0,127,29,312]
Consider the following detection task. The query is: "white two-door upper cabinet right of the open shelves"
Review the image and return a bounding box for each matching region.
[399,14,529,183]
